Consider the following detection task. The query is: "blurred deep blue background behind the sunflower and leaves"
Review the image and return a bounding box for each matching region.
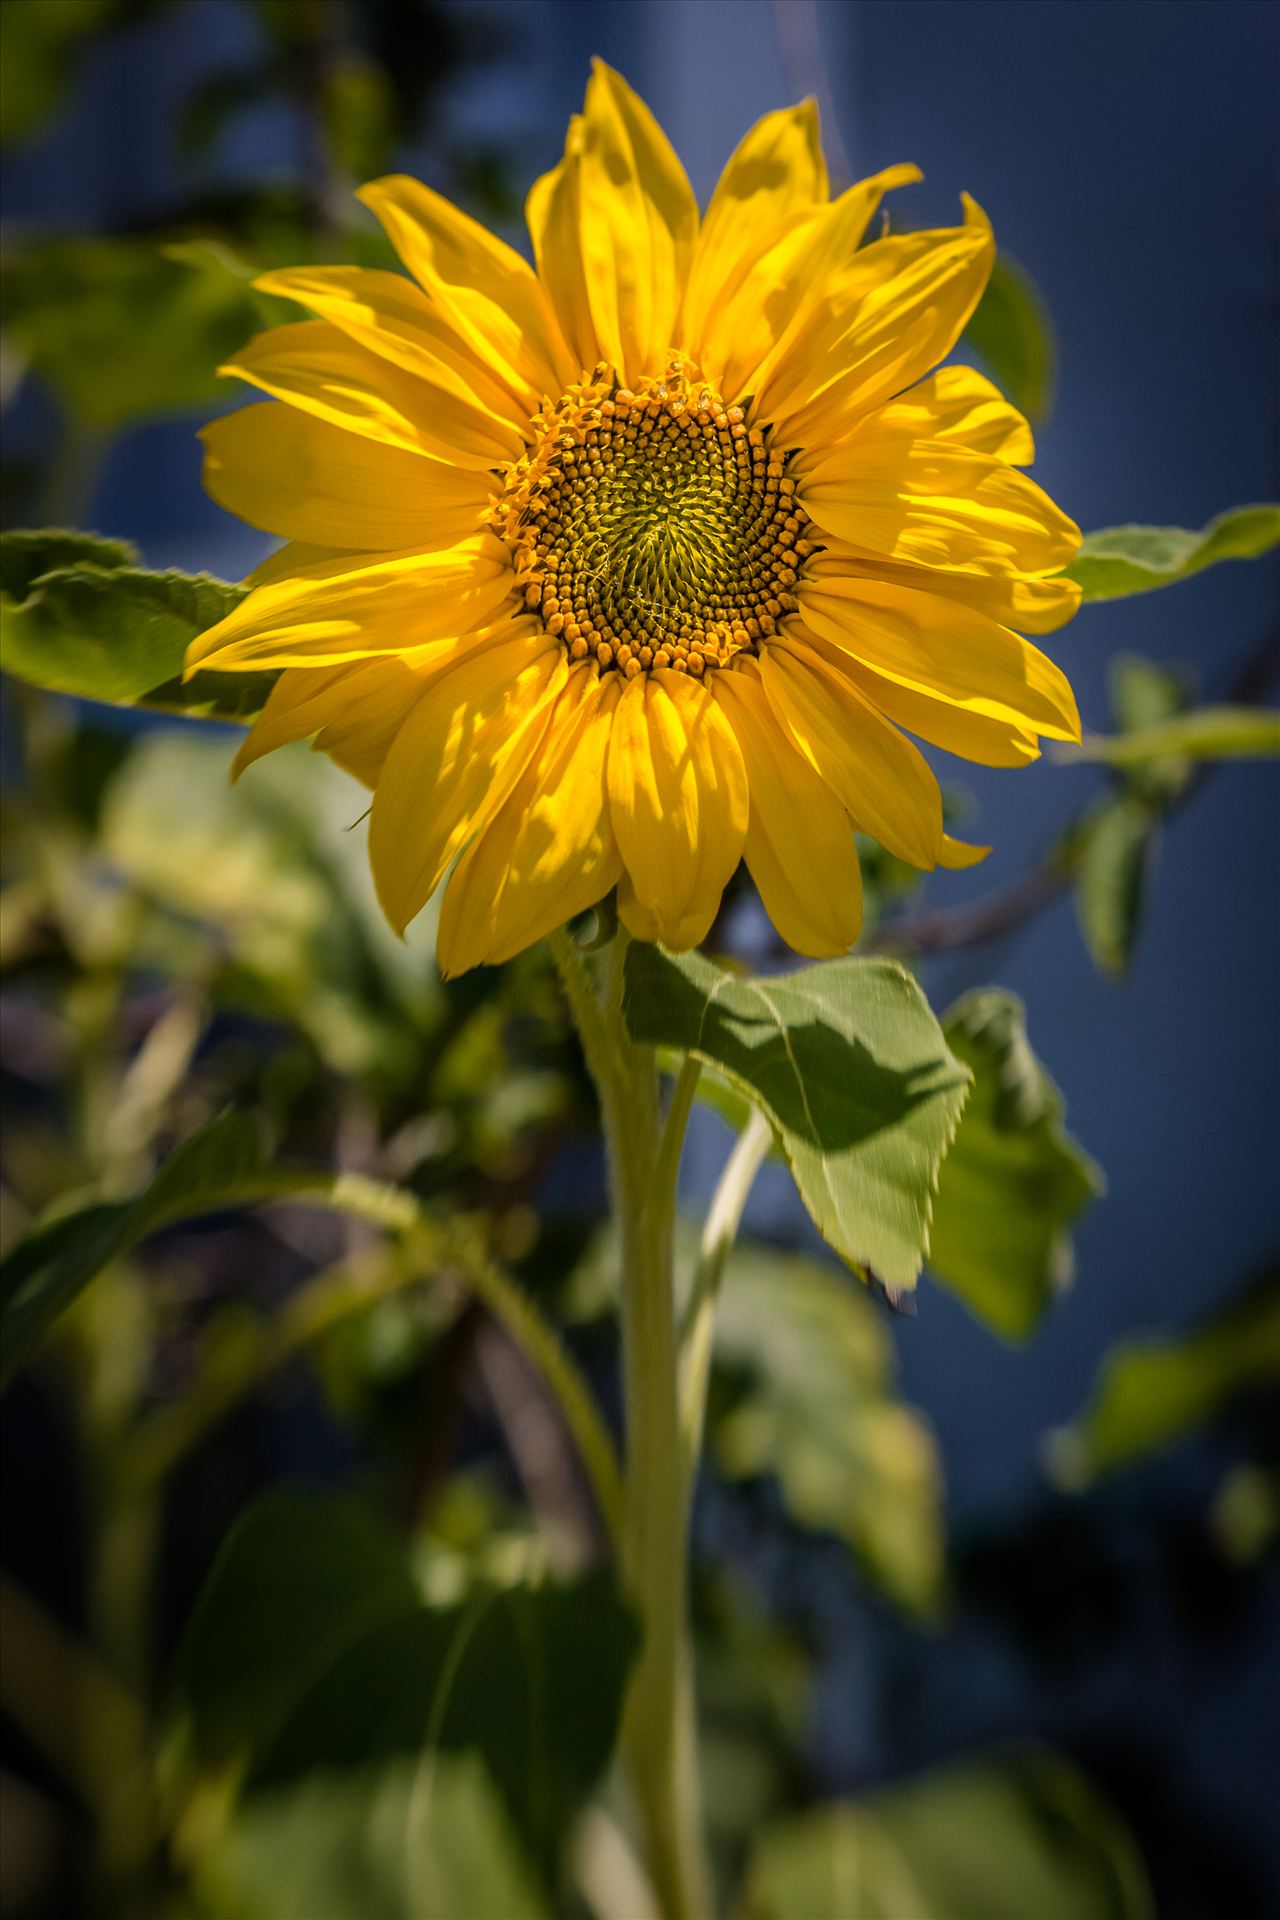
[6,0,1280,1904]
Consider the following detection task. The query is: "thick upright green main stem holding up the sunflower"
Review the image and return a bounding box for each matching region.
[551,933,710,1920]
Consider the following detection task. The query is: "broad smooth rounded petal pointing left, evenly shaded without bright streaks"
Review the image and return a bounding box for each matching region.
[200,399,493,551]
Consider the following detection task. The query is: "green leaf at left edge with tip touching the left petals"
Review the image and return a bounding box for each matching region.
[0,532,262,720]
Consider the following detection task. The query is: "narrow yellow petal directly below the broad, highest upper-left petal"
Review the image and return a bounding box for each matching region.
[253,267,541,426]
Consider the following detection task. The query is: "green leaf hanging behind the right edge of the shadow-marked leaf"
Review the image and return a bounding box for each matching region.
[929,987,1102,1340]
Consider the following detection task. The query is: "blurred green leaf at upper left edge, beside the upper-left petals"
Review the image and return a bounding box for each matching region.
[2,236,261,432]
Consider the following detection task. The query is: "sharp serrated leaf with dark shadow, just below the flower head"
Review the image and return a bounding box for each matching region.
[622,941,969,1288]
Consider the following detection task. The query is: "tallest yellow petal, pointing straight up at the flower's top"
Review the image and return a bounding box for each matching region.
[530,60,699,380]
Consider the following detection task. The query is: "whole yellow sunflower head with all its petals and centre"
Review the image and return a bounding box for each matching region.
[188,63,1080,973]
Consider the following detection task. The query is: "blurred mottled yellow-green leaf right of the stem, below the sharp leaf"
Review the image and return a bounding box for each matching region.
[710,1244,942,1619]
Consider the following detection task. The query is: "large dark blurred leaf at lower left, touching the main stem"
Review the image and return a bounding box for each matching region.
[177,1496,637,1885]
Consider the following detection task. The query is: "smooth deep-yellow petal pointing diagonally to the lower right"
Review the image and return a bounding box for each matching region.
[760,637,942,868]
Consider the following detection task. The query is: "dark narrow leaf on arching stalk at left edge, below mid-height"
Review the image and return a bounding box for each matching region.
[0,1112,415,1382]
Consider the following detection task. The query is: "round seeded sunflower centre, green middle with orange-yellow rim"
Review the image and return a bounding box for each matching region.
[493,361,814,678]
